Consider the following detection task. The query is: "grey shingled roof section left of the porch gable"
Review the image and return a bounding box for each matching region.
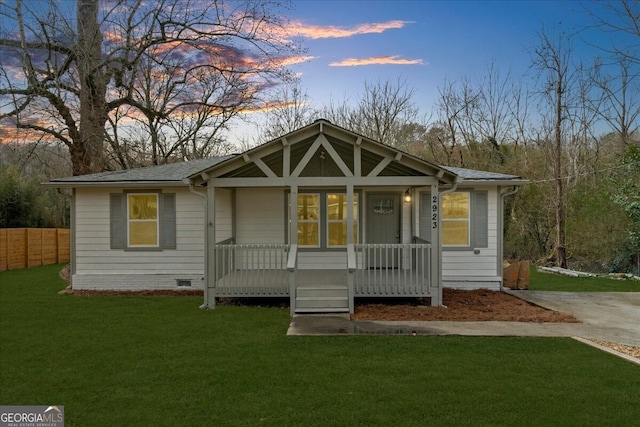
[48,155,235,188]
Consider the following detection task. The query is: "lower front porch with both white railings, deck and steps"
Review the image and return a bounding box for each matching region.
[213,240,432,315]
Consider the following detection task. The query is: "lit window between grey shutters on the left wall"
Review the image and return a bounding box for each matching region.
[127,193,160,248]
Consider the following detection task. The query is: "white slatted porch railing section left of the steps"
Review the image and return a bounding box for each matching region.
[214,242,290,296]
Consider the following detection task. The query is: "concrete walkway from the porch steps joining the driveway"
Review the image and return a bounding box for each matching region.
[287,291,640,347]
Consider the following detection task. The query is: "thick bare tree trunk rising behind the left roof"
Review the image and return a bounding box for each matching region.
[71,0,107,175]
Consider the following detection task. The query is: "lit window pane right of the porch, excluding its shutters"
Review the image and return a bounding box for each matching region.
[441,192,471,246]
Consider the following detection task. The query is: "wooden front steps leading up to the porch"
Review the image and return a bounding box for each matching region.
[295,285,349,313]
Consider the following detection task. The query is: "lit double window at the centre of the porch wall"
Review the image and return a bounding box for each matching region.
[288,192,358,248]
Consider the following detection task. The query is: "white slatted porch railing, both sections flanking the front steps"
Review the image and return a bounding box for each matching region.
[214,240,431,300]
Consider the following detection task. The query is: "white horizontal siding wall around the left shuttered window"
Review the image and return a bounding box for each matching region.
[73,188,204,289]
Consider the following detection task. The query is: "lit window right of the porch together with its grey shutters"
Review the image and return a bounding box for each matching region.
[420,190,489,250]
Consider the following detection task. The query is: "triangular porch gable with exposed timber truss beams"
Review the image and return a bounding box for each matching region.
[201,121,455,187]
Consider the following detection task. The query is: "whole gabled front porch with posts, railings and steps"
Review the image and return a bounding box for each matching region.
[190,120,456,314]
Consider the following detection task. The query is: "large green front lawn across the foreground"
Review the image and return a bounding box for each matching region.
[0,266,640,426]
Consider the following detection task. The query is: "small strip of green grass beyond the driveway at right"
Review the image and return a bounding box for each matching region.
[529,266,640,292]
